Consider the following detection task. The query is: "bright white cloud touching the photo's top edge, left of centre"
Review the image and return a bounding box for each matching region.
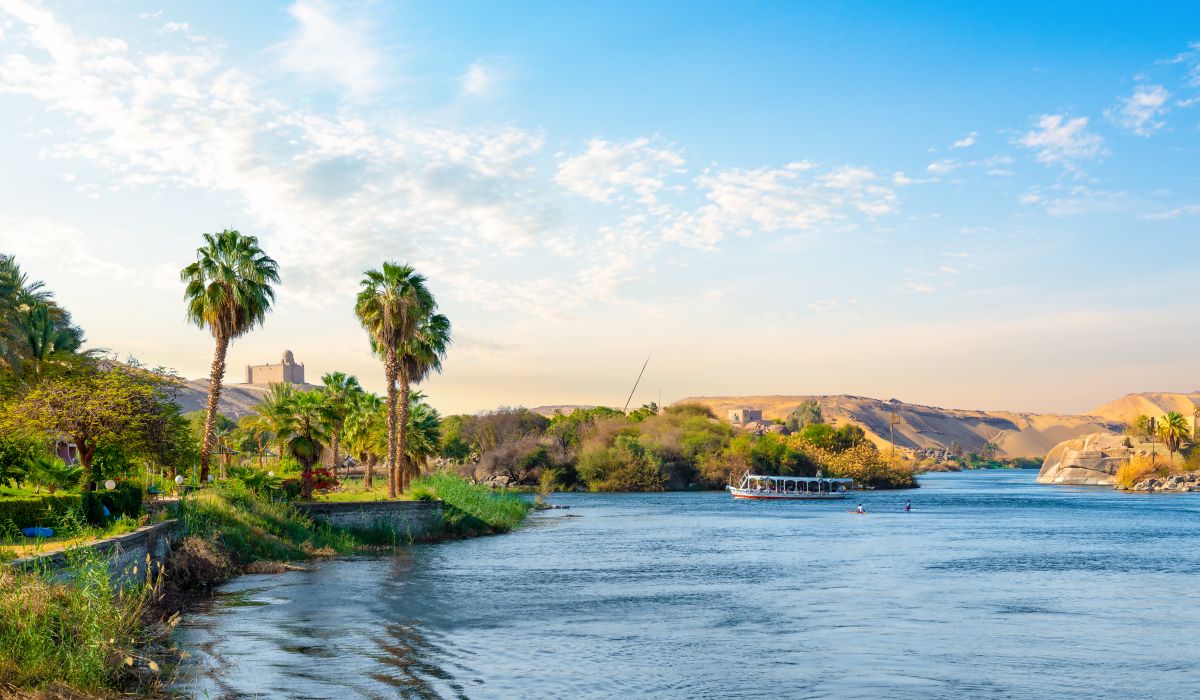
[278,0,383,98]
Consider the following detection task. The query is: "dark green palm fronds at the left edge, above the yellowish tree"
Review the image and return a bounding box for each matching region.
[0,255,84,378]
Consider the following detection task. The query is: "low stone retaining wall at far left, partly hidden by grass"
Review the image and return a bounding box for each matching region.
[12,520,180,585]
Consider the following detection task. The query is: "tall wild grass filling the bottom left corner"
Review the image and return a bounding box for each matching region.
[0,540,160,696]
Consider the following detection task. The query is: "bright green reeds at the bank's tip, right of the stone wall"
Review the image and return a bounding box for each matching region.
[410,472,532,534]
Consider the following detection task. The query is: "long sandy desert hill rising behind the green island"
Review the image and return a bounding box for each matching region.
[679,396,1136,457]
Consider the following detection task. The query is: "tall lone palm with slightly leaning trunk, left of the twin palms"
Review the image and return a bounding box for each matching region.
[180,229,280,480]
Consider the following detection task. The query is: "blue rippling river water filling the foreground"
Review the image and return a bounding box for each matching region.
[176,471,1200,699]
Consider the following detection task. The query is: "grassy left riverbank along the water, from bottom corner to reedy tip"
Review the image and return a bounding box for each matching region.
[0,475,529,698]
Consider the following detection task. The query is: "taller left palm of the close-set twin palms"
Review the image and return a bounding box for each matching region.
[354,263,437,498]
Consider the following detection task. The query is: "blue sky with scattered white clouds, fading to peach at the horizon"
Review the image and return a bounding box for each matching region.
[0,0,1200,413]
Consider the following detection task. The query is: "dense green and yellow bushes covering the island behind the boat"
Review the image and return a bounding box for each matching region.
[442,403,916,491]
